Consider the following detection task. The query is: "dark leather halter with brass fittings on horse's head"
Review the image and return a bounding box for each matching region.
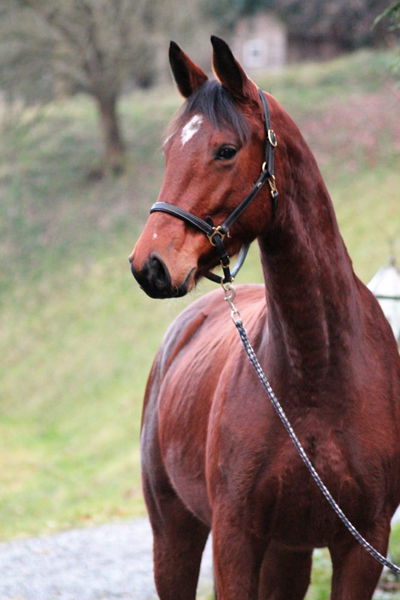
[150,88,279,284]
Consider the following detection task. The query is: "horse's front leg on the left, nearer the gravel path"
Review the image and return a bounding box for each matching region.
[212,503,267,600]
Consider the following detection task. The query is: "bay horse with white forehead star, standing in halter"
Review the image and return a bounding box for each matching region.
[130,37,400,600]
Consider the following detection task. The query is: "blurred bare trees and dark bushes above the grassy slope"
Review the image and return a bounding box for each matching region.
[0,0,398,174]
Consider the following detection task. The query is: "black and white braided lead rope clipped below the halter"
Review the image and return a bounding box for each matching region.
[222,284,400,575]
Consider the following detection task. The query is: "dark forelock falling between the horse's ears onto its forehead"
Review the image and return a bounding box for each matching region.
[167,80,250,143]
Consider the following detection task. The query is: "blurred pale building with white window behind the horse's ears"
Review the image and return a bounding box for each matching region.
[231,12,287,74]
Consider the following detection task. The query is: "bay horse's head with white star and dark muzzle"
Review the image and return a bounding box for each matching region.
[130,37,280,298]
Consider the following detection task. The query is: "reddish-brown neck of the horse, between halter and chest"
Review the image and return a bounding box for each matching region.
[259,139,360,386]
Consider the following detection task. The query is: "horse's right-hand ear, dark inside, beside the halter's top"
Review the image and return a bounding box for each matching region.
[211,35,258,100]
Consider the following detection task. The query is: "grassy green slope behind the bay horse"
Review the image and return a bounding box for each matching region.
[0,47,400,600]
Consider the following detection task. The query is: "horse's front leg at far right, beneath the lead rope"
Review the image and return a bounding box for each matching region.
[329,519,390,600]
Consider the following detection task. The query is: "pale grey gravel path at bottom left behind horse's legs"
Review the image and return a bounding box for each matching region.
[0,519,212,600]
